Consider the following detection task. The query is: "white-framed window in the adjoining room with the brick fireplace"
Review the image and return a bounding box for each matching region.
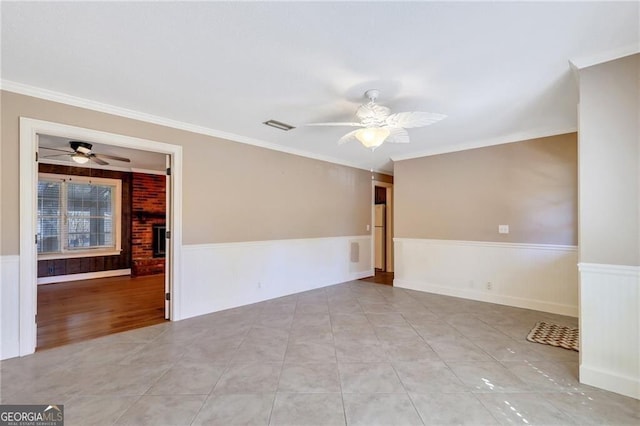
[38,173,122,258]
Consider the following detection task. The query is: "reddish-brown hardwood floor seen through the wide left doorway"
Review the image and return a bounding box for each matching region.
[37,275,165,350]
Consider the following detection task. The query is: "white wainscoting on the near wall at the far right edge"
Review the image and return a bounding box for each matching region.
[578,263,640,399]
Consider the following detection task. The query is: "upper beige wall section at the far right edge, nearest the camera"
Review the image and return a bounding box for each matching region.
[579,55,640,266]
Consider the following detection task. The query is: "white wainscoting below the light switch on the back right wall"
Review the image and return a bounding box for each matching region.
[394,238,578,317]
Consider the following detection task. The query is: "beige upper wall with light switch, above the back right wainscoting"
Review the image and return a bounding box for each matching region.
[394,133,577,245]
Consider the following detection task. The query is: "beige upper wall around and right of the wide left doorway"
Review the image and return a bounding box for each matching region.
[0,91,371,255]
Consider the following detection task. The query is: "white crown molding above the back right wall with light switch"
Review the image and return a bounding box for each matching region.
[391,126,578,161]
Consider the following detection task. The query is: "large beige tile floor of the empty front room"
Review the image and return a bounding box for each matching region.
[0,281,640,426]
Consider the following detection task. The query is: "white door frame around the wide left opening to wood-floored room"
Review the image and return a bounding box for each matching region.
[19,117,182,356]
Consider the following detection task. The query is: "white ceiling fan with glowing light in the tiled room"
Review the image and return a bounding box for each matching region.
[307,89,447,149]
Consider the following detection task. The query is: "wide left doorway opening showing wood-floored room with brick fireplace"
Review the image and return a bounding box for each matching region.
[36,160,169,351]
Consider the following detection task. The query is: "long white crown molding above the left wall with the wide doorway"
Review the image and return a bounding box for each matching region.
[0,80,380,174]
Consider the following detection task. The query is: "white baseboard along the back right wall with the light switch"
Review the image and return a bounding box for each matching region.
[393,279,578,317]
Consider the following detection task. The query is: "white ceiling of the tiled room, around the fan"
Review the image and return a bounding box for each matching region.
[1,1,640,171]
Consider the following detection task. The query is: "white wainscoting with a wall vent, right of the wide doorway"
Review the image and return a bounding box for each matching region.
[180,236,373,319]
